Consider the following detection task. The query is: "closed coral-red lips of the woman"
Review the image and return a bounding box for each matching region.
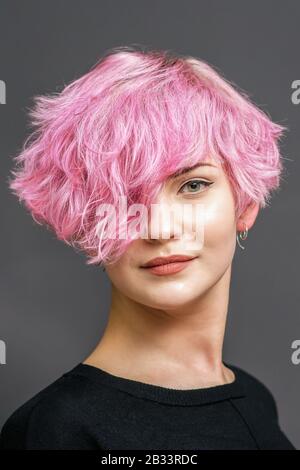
[141,255,198,276]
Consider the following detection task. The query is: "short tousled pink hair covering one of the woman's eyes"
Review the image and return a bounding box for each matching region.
[9,46,285,264]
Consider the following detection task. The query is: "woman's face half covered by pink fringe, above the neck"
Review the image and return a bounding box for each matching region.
[105,160,237,310]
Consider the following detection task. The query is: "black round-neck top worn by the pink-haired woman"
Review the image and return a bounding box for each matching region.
[0,362,296,450]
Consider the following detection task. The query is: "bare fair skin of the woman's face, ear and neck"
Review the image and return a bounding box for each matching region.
[83,159,259,389]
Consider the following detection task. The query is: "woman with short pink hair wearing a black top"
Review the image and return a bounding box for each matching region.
[1,47,295,450]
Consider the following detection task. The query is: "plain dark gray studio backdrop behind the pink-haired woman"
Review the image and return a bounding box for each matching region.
[0,0,300,448]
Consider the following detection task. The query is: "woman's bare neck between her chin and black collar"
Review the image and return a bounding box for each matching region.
[85,266,234,388]
